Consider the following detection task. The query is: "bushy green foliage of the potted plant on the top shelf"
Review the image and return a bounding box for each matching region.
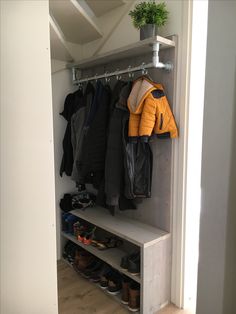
[129,1,169,29]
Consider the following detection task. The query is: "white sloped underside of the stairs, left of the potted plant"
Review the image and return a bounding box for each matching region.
[49,0,128,61]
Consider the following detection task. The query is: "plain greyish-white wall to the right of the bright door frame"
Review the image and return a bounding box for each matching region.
[197,1,236,314]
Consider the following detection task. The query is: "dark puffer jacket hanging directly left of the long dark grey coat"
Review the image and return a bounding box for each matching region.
[79,81,111,188]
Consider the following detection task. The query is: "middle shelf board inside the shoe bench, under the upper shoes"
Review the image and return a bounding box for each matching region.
[61,232,141,283]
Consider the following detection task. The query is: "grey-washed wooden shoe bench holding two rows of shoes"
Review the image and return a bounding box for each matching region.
[61,207,171,314]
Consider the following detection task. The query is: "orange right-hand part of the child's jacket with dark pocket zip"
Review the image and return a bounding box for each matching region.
[154,95,178,138]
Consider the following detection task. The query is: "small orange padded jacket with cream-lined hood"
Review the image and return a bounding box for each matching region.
[128,77,178,140]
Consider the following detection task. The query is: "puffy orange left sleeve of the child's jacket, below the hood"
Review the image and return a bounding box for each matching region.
[139,95,156,141]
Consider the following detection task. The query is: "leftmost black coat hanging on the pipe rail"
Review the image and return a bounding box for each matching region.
[60,90,83,176]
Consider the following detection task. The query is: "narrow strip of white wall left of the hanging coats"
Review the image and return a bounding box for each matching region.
[52,70,77,259]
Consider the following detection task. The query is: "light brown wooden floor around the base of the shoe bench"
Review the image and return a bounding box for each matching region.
[58,261,192,314]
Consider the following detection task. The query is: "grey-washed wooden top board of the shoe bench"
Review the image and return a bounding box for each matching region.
[70,207,170,247]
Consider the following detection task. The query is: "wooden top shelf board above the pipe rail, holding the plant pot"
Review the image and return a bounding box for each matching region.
[68,36,175,70]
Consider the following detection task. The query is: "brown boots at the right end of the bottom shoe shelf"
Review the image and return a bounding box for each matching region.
[121,277,140,312]
